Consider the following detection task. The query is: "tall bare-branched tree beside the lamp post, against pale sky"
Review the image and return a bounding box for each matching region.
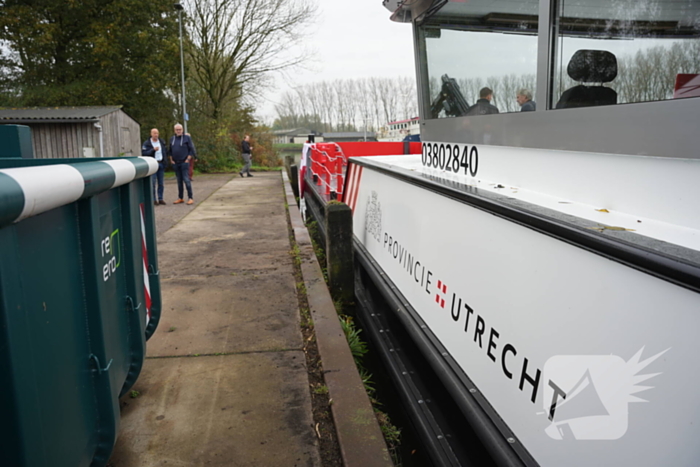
[187,0,313,120]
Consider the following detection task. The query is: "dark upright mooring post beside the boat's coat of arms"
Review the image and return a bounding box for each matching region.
[326,201,355,305]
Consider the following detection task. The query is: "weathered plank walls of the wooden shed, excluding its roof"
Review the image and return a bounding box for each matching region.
[29,110,141,159]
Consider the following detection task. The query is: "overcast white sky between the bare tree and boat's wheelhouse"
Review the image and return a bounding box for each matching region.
[257,0,415,123]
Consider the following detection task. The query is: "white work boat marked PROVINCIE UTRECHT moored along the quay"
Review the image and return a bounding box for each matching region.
[306,0,700,467]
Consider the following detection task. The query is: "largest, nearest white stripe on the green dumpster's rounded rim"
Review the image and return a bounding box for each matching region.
[0,164,85,222]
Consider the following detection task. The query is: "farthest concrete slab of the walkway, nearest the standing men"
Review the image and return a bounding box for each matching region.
[158,173,293,278]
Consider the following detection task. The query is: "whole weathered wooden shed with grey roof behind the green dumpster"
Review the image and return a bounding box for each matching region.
[0,106,141,159]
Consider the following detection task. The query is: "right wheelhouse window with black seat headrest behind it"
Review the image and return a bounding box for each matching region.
[552,0,700,109]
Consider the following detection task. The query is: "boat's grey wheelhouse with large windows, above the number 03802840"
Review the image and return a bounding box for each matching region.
[386,0,700,158]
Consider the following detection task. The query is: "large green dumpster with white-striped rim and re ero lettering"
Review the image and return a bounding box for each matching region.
[0,126,161,467]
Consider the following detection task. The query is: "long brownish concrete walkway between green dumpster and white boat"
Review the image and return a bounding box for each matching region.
[109,172,320,467]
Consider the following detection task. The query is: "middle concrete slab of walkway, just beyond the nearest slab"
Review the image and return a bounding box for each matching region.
[148,271,302,357]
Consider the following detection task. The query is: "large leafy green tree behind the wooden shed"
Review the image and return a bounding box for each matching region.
[0,0,179,137]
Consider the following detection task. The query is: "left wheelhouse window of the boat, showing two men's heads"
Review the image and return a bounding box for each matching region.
[420,0,539,118]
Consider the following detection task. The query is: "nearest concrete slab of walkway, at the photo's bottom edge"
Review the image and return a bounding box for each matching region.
[110,351,320,467]
